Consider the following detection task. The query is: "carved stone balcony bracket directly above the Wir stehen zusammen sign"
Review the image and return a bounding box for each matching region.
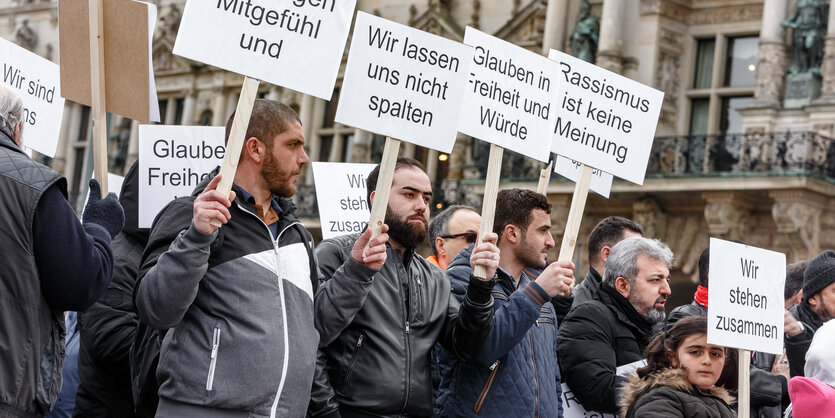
[702,192,754,240]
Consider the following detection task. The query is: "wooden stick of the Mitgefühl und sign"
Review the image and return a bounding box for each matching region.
[209,76,261,227]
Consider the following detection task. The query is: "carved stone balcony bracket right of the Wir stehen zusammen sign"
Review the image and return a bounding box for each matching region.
[769,190,828,263]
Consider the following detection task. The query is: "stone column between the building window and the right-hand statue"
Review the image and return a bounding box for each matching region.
[750,0,792,109]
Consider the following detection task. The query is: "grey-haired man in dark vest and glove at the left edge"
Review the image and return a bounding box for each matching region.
[0,85,125,416]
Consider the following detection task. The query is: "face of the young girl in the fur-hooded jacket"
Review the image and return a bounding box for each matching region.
[667,334,725,390]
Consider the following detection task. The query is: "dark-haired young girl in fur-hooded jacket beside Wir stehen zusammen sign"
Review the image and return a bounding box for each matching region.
[620,315,736,418]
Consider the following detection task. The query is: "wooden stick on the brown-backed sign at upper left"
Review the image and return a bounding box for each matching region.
[89,0,107,198]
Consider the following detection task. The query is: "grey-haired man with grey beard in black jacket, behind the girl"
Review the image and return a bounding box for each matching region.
[557,238,673,413]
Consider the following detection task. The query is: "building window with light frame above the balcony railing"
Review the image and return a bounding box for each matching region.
[685,33,759,135]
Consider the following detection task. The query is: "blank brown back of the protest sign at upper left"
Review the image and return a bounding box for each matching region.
[58,0,160,123]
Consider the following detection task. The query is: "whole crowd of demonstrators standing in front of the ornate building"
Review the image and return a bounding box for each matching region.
[0,87,835,418]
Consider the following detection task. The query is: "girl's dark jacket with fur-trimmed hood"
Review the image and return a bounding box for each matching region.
[619,368,735,417]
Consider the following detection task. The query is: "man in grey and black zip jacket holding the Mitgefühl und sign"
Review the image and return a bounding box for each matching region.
[135,100,386,417]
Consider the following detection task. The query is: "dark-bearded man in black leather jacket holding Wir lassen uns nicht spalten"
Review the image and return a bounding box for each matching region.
[309,158,499,417]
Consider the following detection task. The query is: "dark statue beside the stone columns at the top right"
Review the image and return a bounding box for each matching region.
[780,0,829,74]
